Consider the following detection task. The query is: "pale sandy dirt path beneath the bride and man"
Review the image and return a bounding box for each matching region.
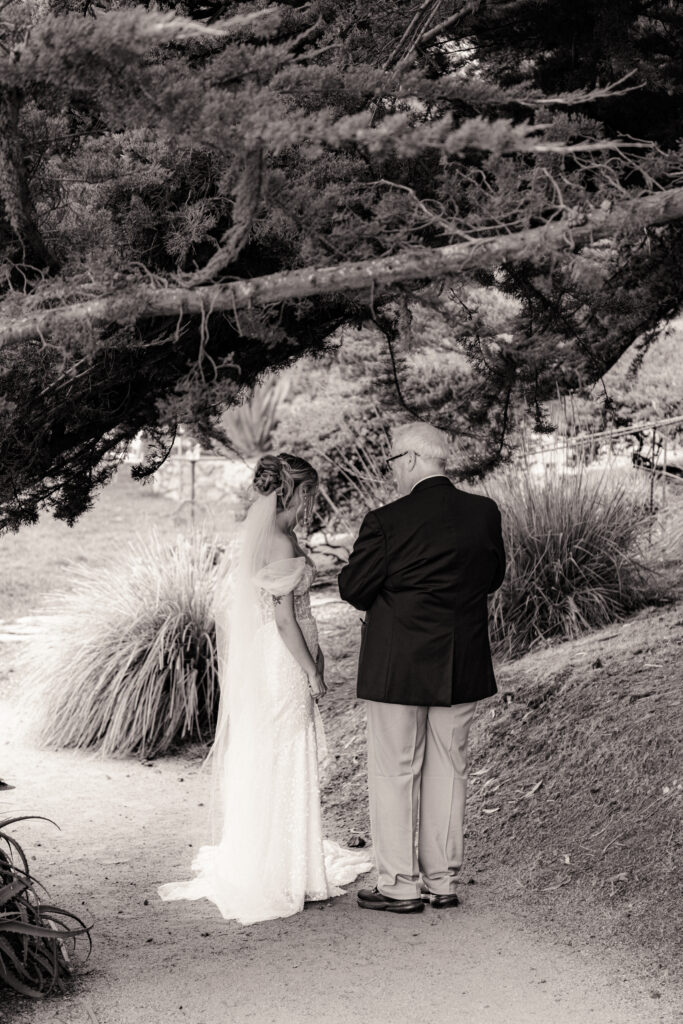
[0,599,683,1024]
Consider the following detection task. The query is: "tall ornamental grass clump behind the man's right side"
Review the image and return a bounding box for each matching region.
[486,467,656,657]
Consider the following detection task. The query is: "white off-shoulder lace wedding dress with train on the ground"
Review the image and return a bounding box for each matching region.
[159,544,373,925]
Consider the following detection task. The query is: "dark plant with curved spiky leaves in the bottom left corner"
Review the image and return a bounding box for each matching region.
[0,814,91,999]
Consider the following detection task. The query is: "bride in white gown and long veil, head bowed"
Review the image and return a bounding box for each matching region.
[159,453,373,925]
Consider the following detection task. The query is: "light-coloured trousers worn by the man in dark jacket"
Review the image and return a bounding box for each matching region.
[366,700,476,899]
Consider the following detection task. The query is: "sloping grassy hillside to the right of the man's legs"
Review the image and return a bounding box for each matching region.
[470,602,683,966]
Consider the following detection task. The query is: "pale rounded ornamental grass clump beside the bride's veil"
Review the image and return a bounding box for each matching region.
[24,531,218,757]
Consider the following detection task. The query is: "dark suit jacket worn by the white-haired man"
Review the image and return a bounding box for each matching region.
[339,476,505,707]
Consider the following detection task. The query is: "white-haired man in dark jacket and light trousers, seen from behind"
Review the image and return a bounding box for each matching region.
[339,423,505,913]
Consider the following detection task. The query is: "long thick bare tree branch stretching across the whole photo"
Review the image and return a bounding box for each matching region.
[0,186,683,347]
